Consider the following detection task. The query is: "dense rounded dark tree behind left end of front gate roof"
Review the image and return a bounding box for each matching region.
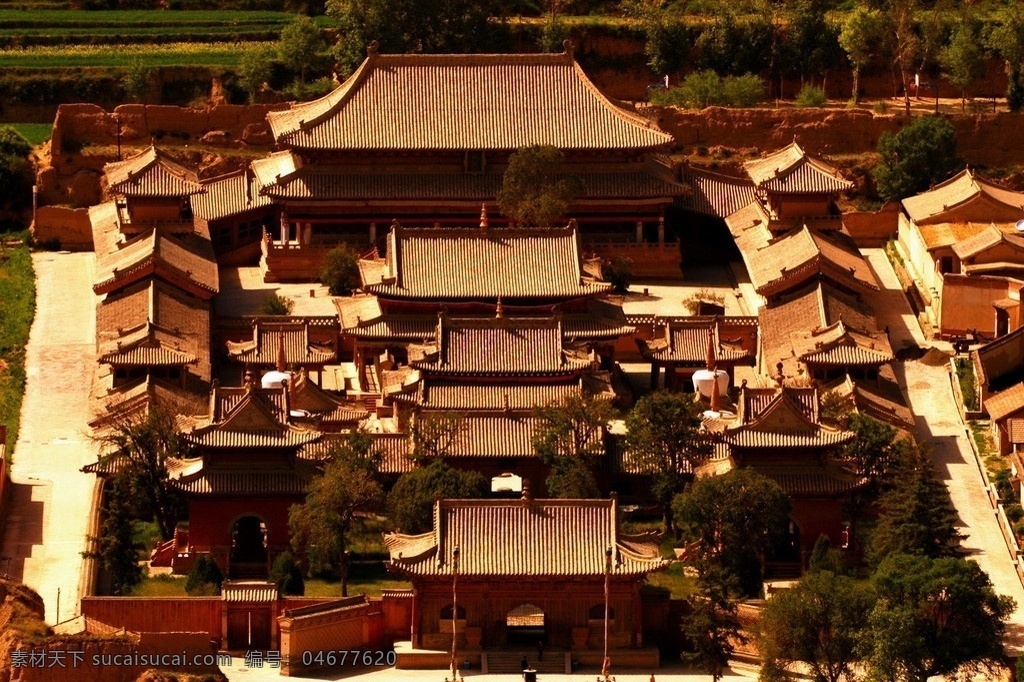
[387,458,488,535]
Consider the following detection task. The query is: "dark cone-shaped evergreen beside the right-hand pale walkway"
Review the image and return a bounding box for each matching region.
[870,438,962,563]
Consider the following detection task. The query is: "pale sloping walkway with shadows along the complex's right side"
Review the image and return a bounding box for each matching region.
[863,249,1024,652]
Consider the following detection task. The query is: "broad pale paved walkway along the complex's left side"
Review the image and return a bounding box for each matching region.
[0,253,96,623]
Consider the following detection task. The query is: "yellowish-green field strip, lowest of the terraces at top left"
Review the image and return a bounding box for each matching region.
[0,43,274,69]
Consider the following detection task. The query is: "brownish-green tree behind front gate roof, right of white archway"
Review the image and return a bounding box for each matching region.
[532,395,614,499]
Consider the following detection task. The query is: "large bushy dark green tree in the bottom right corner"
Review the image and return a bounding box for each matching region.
[867,554,1015,682]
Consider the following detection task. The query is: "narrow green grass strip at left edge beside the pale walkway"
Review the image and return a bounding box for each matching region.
[0,235,36,457]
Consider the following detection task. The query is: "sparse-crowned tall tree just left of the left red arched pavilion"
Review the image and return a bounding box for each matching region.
[97,404,196,541]
